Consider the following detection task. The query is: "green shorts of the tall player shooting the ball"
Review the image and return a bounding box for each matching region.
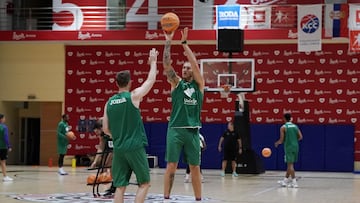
[165,128,200,166]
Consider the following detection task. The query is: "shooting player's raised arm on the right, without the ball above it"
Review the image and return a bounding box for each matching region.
[181,27,205,93]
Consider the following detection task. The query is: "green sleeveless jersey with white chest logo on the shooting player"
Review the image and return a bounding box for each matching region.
[169,80,204,127]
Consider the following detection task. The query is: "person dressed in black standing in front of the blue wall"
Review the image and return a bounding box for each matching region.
[218,122,242,177]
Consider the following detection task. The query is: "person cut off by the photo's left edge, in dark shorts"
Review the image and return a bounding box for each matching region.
[0,114,13,182]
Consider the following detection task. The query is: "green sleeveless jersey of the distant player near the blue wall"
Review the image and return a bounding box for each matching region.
[284,122,299,151]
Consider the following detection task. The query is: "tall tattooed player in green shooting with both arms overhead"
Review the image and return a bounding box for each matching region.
[163,28,204,201]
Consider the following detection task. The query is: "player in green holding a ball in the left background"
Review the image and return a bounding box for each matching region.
[57,114,70,175]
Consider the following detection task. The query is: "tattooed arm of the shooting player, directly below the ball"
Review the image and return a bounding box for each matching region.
[163,32,181,89]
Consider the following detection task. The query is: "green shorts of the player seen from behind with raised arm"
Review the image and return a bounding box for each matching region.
[111,148,150,187]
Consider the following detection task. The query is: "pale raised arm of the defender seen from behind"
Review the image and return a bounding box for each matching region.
[131,48,159,107]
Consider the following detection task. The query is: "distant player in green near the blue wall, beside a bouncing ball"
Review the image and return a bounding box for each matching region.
[275,113,303,188]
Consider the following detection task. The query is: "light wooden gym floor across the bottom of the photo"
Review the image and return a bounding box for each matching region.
[0,166,360,203]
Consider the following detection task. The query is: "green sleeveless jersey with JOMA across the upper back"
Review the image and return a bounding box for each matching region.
[106,92,148,152]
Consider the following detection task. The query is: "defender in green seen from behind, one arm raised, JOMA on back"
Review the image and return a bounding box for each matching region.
[103,48,159,203]
